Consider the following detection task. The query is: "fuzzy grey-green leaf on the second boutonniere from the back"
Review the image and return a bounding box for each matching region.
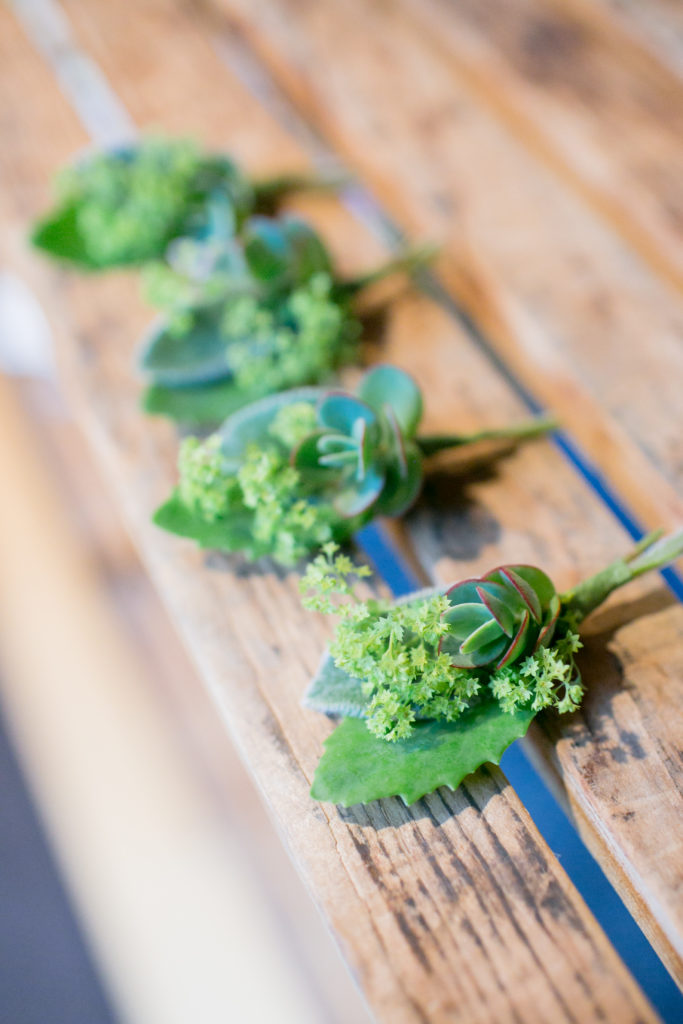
[138,305,230,387]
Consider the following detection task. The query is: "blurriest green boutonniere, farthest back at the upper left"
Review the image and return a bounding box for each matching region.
[32,136,333,270]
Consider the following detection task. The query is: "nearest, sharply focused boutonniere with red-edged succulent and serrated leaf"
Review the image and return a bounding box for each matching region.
[301,530,683,807]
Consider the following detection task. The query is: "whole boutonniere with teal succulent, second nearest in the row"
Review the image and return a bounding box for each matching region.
[155,366,550,565]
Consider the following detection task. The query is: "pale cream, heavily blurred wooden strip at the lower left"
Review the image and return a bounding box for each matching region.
[0,376,364,1024]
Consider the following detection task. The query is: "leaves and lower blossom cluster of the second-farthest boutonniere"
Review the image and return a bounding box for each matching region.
[138,272,359,425]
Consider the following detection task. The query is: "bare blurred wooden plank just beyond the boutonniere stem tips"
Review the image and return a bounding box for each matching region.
[215,0,683,536]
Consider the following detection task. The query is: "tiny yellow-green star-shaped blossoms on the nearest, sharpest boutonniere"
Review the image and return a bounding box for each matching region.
[301,544,583,740]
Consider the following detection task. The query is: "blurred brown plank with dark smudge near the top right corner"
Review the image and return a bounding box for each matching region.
[393,0,683,290]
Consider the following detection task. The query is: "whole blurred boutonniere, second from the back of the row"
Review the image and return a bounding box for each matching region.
[139,215,432,424]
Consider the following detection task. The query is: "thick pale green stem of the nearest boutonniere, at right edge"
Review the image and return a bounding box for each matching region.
[561,529,683,622]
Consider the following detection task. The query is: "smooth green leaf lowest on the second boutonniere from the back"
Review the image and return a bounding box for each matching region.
[141,380,255,427]
